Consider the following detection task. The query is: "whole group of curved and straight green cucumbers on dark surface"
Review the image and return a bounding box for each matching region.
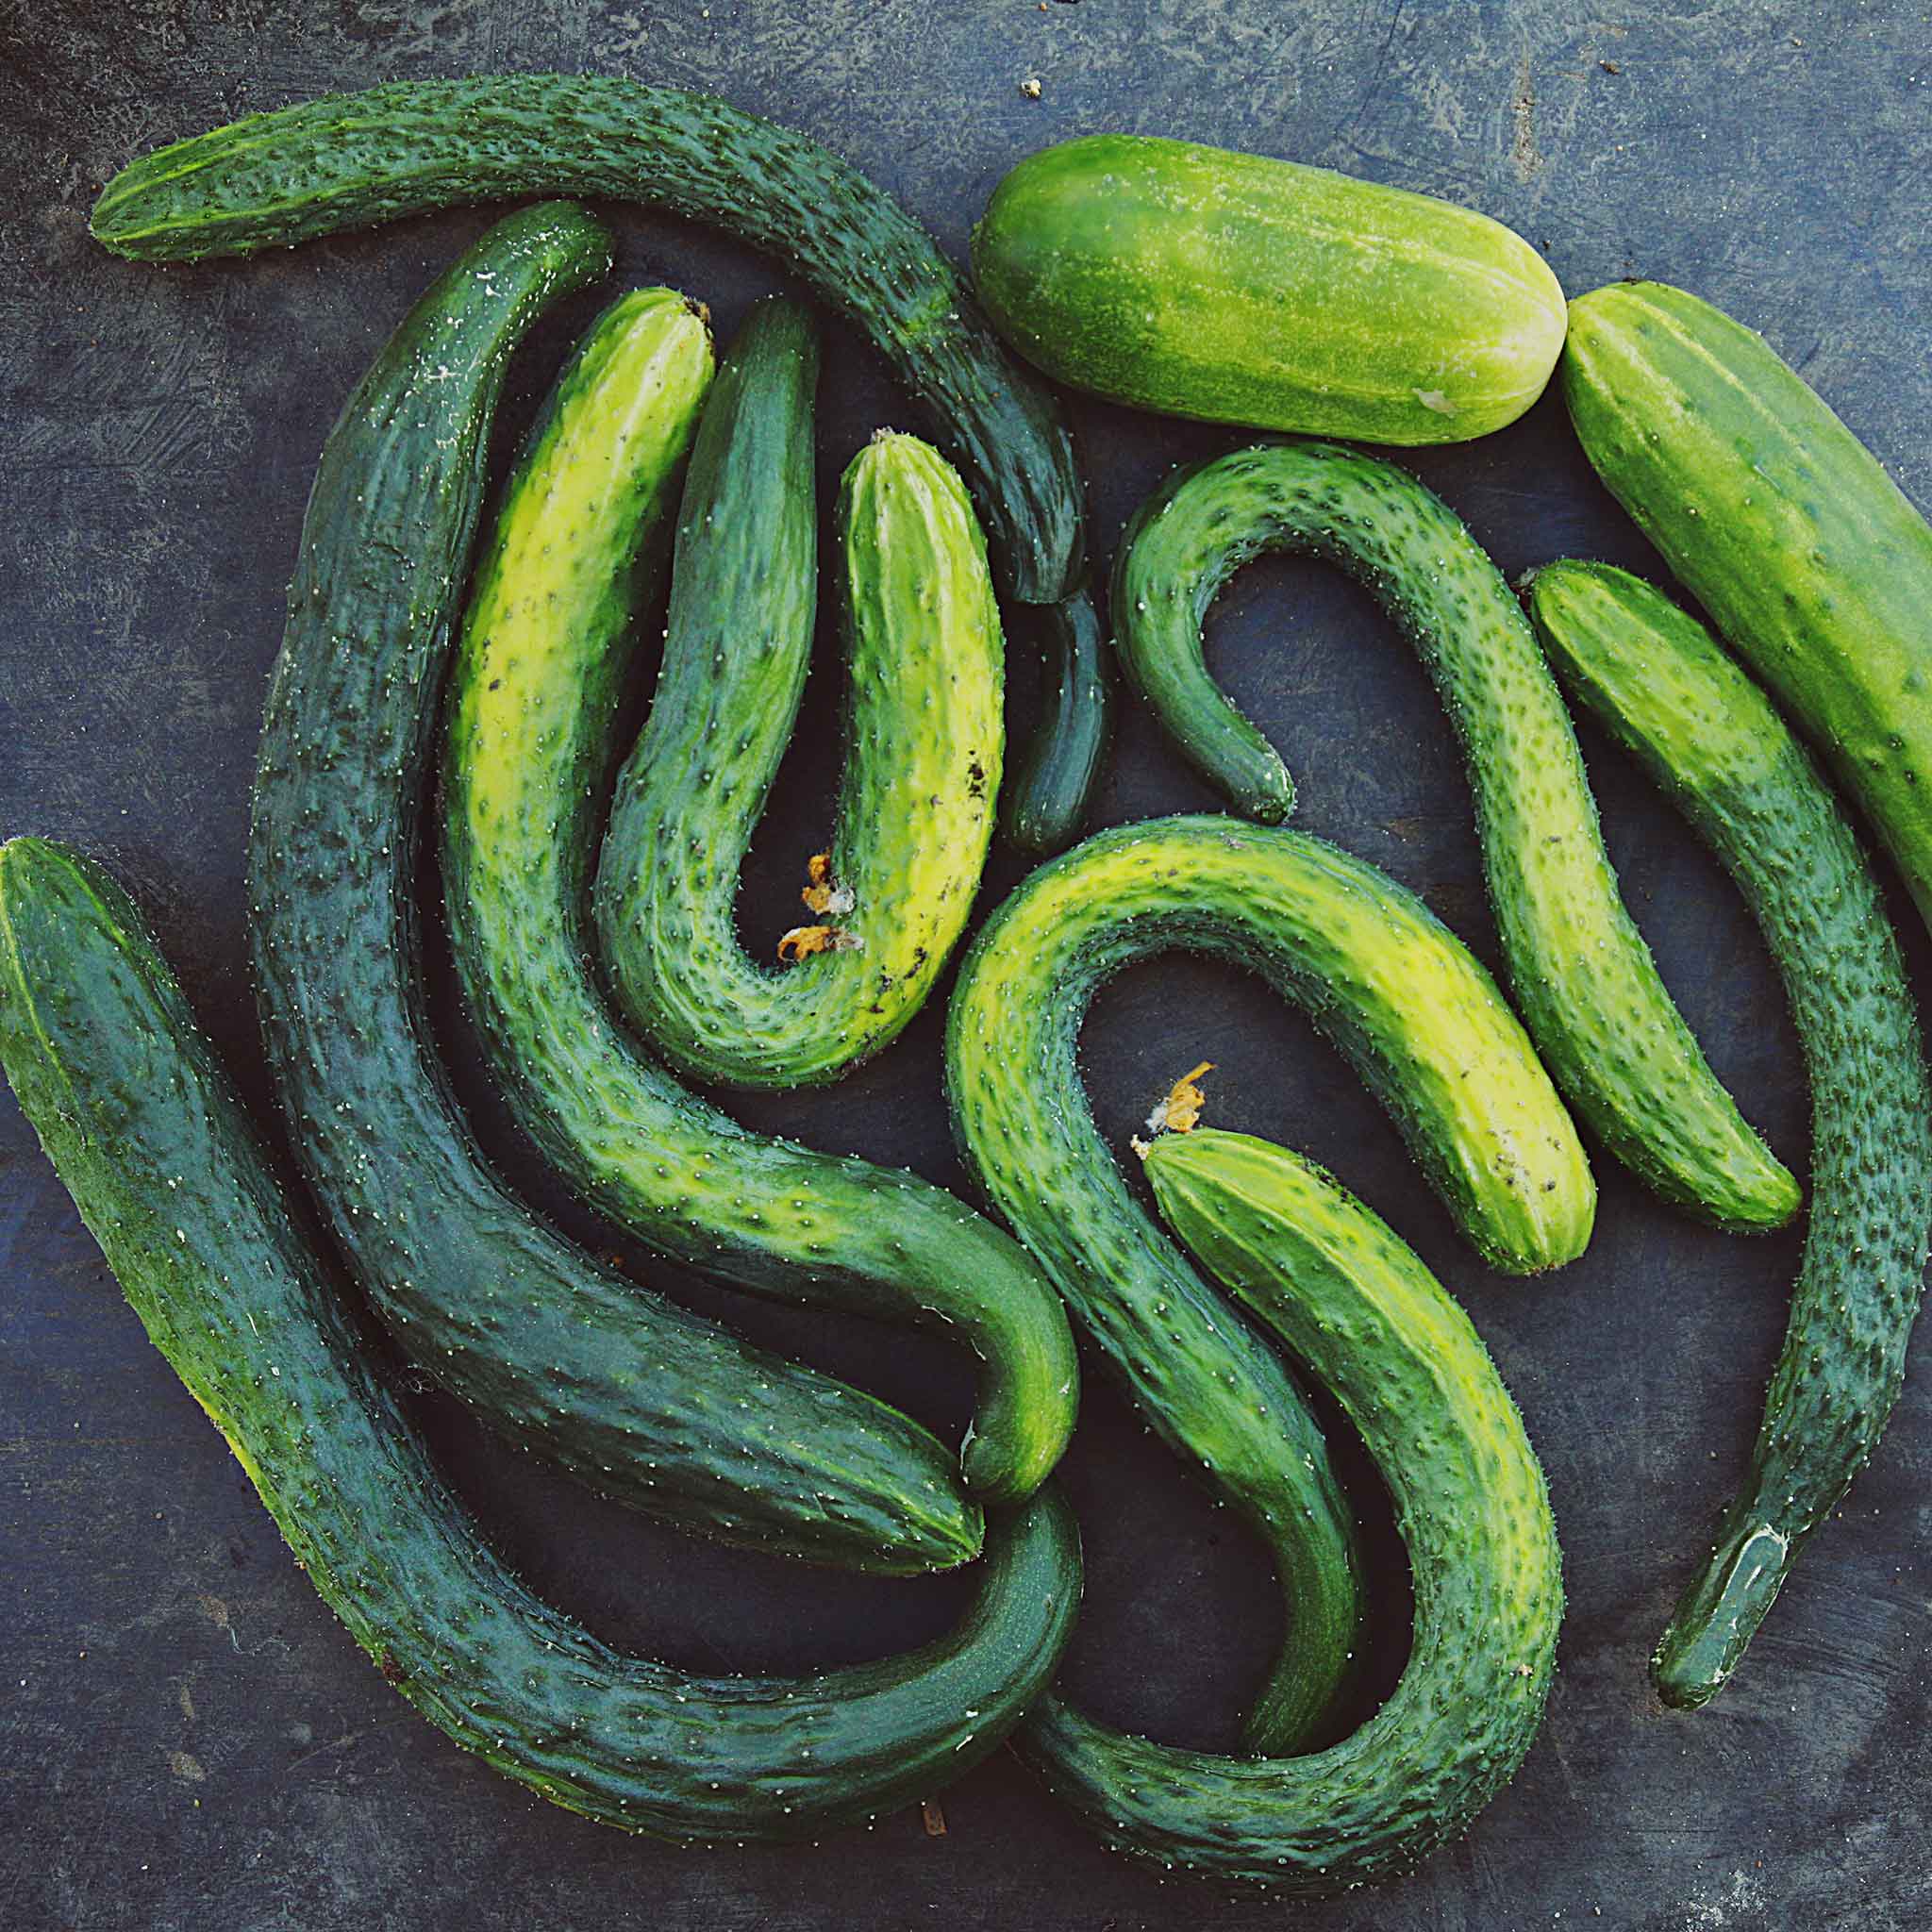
[0,75,1932,1895]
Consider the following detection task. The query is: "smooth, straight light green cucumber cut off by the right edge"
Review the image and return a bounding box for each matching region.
[1561,282,1932,942]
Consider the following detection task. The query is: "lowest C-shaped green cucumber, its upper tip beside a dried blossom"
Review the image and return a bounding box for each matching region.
[1016,1132,1563,1895]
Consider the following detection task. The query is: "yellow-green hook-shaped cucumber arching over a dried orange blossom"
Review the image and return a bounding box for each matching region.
[947,817,1596,1750]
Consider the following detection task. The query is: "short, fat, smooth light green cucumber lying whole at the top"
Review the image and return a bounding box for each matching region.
[972,133,1563,444]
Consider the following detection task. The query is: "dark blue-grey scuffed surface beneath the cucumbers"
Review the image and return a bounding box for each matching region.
[0,0,1932,1932]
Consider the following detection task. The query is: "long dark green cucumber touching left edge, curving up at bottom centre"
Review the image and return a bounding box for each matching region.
[0,839,1080,1840]
